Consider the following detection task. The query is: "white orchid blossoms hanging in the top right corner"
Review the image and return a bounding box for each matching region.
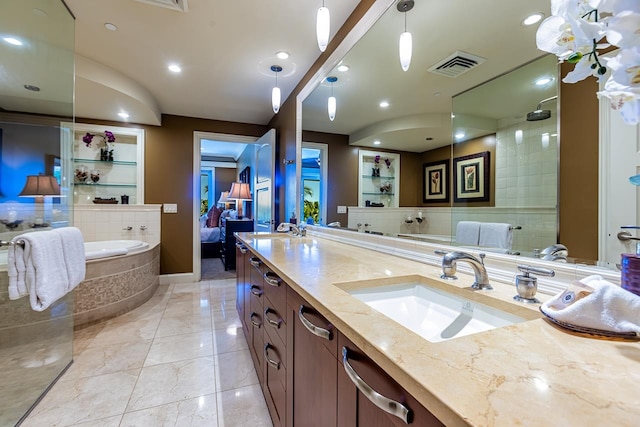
[536,0,640,125]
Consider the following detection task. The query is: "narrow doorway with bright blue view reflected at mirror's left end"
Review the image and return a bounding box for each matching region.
[300,142,329,224]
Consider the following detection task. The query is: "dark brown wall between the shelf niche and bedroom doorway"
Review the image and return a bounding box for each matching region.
[76,115,267,274]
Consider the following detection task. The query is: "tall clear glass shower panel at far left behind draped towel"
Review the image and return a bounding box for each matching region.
[0,0,75,426]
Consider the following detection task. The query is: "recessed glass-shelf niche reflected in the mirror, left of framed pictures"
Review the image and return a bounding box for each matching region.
[358,150,400,208]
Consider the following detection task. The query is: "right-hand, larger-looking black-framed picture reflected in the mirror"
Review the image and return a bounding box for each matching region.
[453,151,490,202]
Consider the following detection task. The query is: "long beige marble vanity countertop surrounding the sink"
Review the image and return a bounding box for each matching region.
[238,233,640,426]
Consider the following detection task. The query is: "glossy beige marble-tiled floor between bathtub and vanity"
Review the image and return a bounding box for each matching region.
[22,279,272,427]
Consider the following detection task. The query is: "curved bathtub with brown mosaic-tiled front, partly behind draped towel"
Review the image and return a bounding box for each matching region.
[0,240,160,329]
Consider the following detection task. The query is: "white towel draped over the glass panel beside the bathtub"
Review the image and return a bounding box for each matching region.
[7,227,85,311]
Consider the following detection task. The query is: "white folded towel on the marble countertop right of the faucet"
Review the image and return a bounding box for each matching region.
[540,275,640,335]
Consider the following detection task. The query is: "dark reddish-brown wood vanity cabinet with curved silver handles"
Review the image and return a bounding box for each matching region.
[237,250,443,427]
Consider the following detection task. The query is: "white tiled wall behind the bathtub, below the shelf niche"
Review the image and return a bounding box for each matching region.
[73,204,162,246]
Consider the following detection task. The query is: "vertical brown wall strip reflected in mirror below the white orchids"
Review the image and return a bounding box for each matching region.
[558,63,599,260]
